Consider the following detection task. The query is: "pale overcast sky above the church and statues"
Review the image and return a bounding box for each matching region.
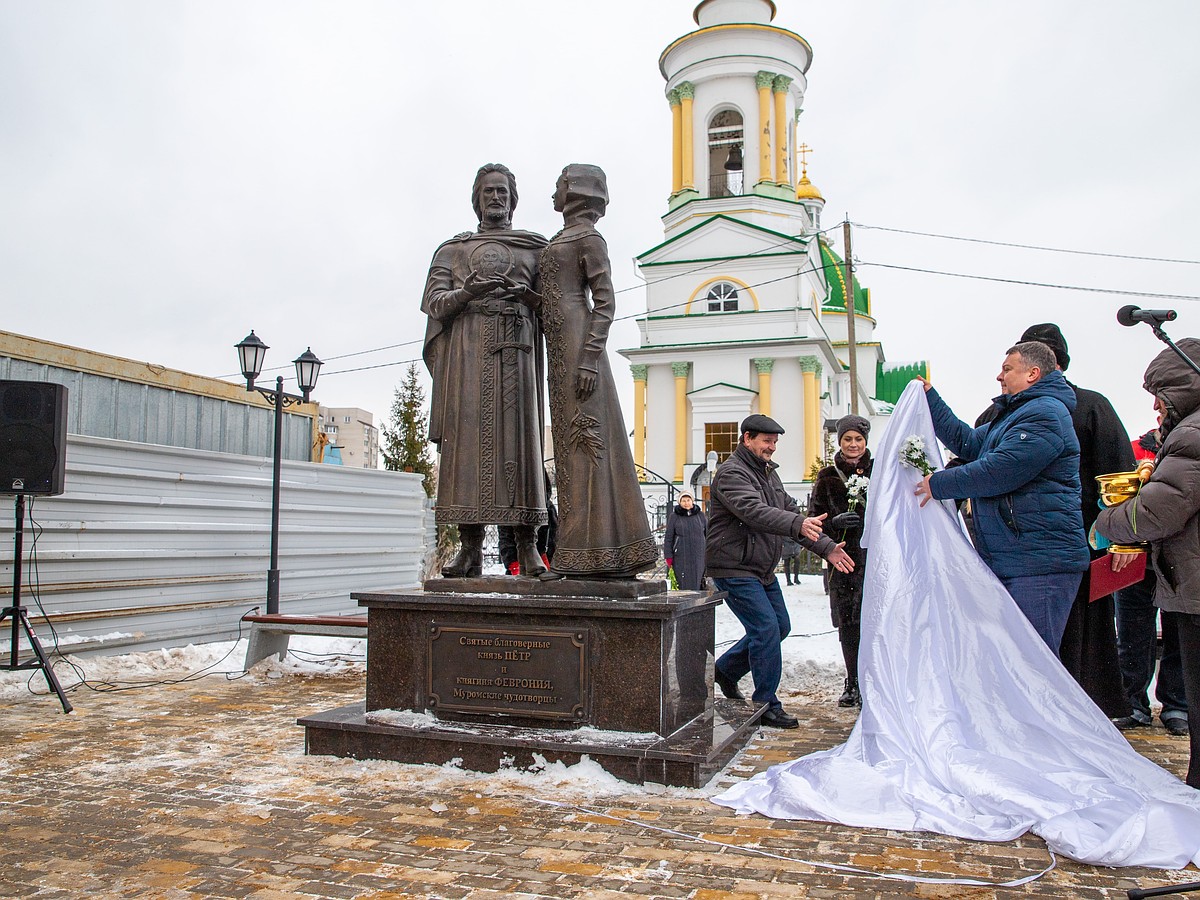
[0,0,1200,460]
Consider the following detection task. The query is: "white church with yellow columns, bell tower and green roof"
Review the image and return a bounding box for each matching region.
[620,0,928,497]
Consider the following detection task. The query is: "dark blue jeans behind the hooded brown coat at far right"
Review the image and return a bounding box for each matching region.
[1116,572,1188,725]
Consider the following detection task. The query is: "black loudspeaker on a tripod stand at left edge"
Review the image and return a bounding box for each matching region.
[0,380,67,496]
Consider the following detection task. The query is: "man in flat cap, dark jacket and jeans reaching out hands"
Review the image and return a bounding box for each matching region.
[706,415,854,728]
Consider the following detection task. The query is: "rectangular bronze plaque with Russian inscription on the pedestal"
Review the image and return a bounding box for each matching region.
[426,624,588,721]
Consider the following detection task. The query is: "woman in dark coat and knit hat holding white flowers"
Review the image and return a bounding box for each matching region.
[809,415,874,707]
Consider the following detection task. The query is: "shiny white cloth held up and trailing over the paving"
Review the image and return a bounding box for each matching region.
[714,382,1200,869]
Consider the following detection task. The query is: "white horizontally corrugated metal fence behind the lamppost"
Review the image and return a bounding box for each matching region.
[0,428,427,654]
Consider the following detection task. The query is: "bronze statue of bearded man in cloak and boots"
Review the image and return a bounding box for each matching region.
[421,163,546,578]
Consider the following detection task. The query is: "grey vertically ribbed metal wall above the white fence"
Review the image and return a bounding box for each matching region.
[0,355,313,460]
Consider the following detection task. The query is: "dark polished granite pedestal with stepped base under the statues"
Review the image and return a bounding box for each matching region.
[300,577,763,787]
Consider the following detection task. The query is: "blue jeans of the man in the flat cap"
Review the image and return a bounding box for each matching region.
[713,578,792,709]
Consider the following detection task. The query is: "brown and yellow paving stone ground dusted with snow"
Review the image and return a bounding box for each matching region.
[0,670,1200,900]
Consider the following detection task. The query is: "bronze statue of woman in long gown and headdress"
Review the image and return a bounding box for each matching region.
[539,164,659,577]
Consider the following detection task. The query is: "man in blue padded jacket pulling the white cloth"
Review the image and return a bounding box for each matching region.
[916,341,1090,654]
